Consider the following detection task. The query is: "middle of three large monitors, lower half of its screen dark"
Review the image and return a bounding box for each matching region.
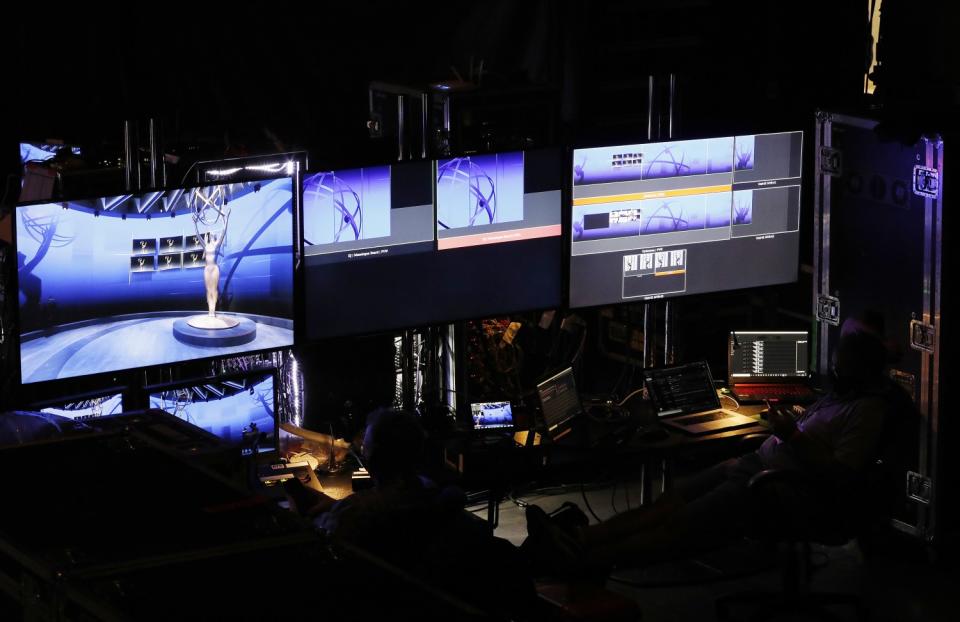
[303,150,563,339]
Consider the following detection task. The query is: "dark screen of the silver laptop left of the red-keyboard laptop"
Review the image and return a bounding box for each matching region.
[643,361,720,417]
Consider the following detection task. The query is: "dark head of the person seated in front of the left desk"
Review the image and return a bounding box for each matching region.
[363,408,424,486]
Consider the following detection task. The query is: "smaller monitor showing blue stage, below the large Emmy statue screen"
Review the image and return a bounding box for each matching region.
[147,370,277,453]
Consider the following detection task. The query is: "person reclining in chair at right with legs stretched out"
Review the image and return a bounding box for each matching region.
[525,320,909,569]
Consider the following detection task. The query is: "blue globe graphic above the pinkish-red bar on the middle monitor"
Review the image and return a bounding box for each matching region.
[437,151,523,229]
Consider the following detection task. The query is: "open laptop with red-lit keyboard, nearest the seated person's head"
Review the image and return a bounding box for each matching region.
[727,331,817,404]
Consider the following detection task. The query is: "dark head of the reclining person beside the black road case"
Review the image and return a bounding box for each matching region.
[832,318,888,391]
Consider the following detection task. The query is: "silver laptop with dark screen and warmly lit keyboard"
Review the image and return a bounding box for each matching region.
[643,361,757,434]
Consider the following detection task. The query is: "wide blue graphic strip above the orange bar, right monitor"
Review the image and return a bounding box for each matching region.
[573,137,740,186]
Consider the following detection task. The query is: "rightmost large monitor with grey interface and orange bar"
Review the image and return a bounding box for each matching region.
[570,132,803,307]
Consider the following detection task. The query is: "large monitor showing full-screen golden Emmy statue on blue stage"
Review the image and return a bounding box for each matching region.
[15,178,294,384]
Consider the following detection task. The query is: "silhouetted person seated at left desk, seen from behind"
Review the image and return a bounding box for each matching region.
[287,410,535,614]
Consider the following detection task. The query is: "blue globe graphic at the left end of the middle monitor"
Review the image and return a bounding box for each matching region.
[303,166,390,246]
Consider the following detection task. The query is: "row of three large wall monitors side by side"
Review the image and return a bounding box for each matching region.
[16,132,802,383]
